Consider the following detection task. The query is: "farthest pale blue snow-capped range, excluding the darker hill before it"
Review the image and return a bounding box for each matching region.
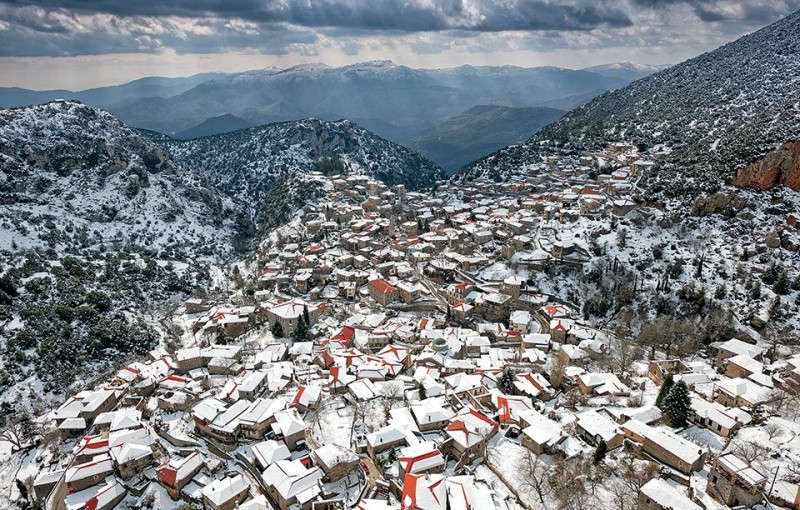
[95,61,631,136]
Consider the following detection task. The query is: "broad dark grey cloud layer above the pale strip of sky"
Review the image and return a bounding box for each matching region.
[0,0,800,56]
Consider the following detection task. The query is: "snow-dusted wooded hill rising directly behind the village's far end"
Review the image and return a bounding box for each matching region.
[160,119,444,216]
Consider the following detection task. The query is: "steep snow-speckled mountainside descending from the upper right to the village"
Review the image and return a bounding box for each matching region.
[460,8,800,200]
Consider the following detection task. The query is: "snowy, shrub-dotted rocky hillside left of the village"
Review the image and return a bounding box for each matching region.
[0,101,252,400]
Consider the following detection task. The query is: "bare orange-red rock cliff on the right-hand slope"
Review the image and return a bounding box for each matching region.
[734,141,800,191]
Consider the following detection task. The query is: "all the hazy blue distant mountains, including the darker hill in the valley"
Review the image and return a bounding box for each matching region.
[0,61,659,172]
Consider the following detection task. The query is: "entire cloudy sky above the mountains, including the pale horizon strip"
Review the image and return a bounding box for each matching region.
[0,0,800,90]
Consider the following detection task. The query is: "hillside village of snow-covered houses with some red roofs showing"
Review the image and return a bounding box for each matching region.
[10,144,800,510]
